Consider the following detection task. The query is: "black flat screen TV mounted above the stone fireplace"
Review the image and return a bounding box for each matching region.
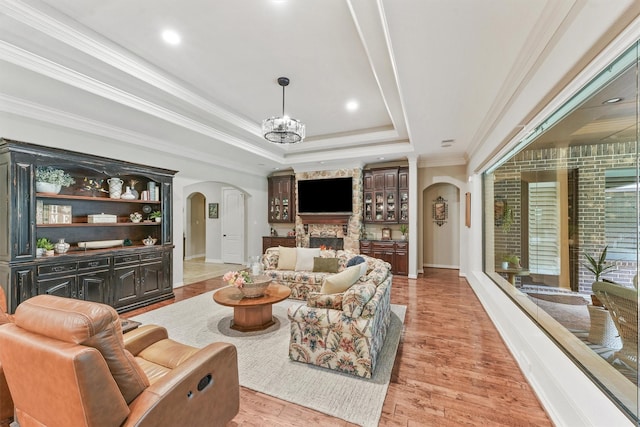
[298,177,353,214]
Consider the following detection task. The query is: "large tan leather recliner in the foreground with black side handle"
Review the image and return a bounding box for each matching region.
[0,295,240,427]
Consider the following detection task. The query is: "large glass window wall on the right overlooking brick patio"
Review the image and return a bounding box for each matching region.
[484,45,640,421]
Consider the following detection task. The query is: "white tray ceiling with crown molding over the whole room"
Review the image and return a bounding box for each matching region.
[0,0,638,174]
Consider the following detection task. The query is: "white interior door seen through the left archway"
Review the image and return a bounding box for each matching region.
[220,188,245,264]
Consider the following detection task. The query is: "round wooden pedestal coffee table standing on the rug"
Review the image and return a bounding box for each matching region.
[213,282,291,332]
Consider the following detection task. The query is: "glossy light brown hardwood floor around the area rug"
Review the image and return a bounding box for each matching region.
[123,269,552,427]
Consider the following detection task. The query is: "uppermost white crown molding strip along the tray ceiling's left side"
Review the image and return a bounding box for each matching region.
[0,0,261,137]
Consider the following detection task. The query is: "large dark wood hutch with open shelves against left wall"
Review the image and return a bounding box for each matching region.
[0,139,176,313]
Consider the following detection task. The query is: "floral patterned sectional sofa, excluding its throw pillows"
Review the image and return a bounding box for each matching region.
[263,248,393,378]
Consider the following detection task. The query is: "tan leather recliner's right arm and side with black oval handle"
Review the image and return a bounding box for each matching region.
[123,342,240,426]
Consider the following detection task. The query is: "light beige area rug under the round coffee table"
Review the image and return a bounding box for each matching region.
[132,292,406,426]
